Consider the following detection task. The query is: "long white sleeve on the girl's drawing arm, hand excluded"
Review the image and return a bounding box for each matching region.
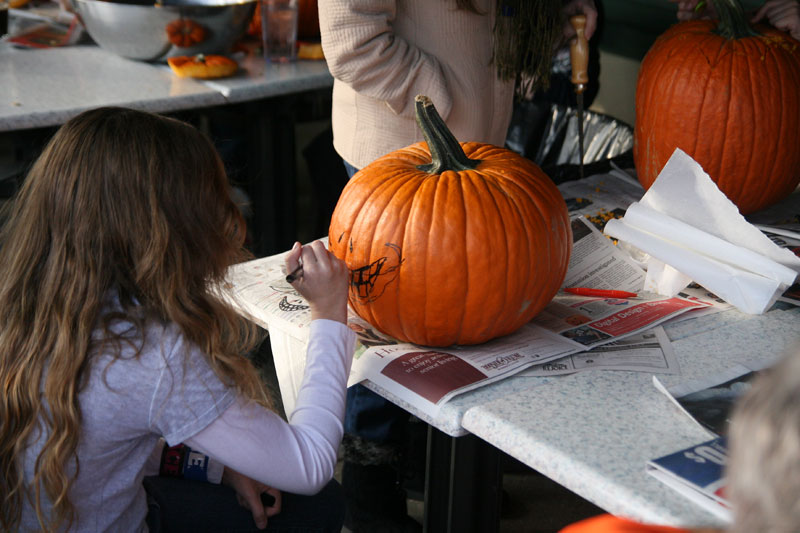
[185,320,355,494]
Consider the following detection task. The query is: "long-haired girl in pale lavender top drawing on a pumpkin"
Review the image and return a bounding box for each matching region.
[0,108,354,532]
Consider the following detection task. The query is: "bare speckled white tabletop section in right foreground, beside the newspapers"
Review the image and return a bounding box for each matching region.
[462,309,800,526]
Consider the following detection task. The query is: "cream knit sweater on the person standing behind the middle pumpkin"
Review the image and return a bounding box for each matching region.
[318,0,514,168]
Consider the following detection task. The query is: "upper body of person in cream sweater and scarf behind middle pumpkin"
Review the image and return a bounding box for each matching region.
[319,0,597,176]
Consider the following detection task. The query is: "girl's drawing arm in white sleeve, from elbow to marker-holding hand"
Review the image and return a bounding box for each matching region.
[186,237,355,494]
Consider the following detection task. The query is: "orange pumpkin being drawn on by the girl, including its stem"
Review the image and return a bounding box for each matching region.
[328,96,572,346]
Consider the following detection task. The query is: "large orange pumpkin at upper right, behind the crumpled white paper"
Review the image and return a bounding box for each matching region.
[634,0,800,214]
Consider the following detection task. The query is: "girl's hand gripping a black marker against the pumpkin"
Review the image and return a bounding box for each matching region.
[286,241,349,324]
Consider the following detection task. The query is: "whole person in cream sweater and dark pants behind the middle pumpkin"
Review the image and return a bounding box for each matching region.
[319,0,597,533]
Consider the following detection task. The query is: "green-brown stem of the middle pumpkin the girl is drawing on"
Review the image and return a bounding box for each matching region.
[414,95,481,174]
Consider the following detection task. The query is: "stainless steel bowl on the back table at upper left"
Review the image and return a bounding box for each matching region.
[75,0,258,61]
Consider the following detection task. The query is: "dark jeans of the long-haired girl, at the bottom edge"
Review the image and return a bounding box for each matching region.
[144,476,345,533]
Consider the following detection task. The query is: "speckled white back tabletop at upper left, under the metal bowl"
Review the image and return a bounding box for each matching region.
[0,43,333,131]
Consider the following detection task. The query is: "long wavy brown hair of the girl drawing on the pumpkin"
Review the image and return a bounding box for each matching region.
[0,108,269,531]
